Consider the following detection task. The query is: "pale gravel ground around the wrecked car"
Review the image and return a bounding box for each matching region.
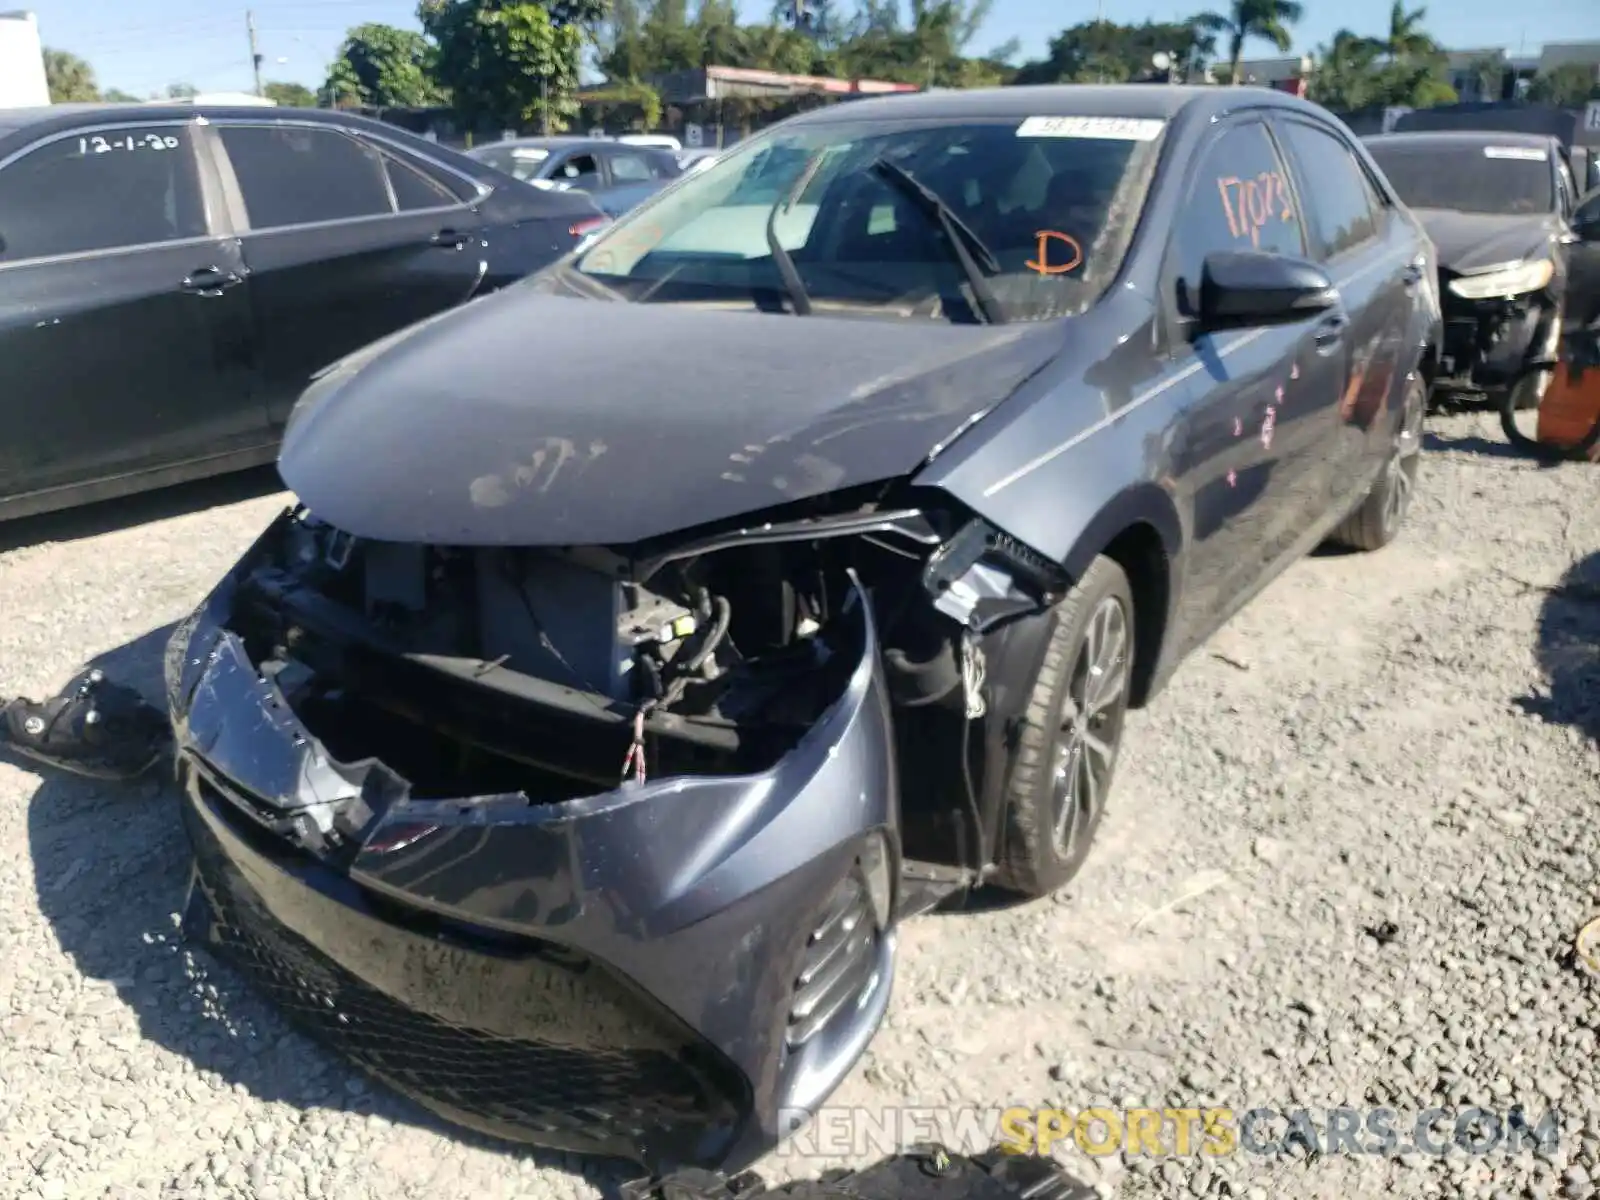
[0,416,1600,1200]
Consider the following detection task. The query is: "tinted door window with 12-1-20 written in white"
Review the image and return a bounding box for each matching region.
[0,125,206,262]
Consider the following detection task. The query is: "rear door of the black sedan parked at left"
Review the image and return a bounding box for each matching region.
[214,122,485,427]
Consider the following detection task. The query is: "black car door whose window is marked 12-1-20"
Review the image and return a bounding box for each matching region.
[0,122,270,507]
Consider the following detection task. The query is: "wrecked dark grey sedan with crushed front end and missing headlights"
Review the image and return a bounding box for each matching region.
[166,85,1438,1168]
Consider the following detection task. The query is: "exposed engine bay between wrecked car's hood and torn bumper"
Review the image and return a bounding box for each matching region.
[216,496,1066,864]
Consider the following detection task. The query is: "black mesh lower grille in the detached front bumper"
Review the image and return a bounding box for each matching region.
[190,793,744,1162]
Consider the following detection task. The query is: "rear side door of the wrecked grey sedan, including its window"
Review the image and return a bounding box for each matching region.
[1275,117,1422,517]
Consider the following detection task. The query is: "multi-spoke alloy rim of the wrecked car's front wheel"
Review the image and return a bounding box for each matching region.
[1051,595,1133,861]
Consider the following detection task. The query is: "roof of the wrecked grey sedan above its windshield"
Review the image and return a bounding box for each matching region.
[790,83,1331,123]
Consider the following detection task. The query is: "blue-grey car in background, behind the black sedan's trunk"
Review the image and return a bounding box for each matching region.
[467,138,682,218]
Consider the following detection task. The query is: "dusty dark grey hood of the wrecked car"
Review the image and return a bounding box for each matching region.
[278,286,1061,546]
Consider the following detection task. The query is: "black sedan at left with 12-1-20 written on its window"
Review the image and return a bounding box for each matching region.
[0,104,603,517]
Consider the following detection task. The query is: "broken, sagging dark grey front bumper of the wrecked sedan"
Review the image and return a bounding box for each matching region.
[168,518,899,1170]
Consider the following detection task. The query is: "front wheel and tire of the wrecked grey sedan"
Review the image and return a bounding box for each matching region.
[995,555,1134,898]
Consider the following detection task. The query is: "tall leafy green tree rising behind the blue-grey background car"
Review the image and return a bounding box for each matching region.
[418,0,592,131]
